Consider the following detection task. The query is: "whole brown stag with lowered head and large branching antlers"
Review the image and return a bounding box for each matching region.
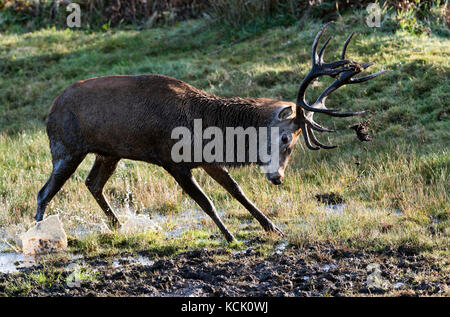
[35,22,385,242]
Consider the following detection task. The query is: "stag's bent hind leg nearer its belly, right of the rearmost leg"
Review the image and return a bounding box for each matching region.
[85,155,120,228]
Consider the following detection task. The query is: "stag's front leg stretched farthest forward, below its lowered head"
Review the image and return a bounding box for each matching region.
[203,165,283,235]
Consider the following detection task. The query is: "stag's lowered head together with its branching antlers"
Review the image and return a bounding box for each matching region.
[266,22,386,185]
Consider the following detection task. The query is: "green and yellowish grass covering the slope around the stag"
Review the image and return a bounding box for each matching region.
[0,15,450,258]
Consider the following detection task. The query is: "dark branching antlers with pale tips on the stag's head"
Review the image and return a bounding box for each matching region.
[297,22,386,150]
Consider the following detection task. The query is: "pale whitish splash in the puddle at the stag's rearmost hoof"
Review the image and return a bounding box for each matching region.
[20,215,67,255]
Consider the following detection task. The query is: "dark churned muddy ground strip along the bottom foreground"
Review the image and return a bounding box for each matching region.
[0,241,450,297]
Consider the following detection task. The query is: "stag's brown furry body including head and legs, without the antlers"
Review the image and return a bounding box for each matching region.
[36,75,300,240]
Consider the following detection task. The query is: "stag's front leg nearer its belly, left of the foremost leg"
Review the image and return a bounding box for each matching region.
[165,167,235,242]
